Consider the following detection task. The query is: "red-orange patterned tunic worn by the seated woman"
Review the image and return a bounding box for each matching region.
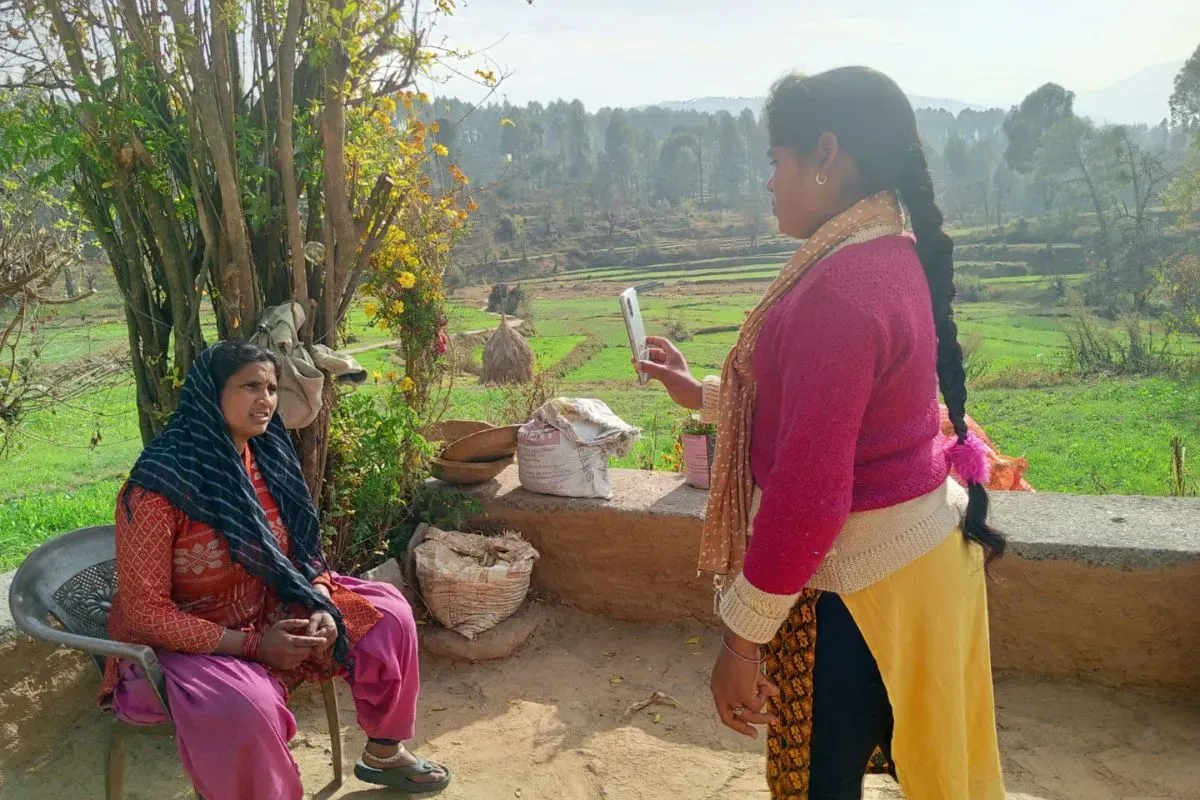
[101,447,382,703]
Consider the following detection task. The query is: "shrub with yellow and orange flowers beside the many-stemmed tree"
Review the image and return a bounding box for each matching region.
[324,92,478,572]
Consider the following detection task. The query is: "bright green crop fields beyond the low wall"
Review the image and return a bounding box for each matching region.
[0,256,1200,569]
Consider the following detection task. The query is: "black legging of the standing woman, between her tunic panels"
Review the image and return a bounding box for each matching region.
[809,591,893,800]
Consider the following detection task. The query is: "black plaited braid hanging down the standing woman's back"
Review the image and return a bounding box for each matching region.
[899,142,1006,563]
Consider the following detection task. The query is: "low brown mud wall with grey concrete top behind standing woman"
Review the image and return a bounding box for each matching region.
[458,469,1200,688]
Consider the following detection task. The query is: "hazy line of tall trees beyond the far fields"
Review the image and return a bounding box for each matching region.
[428,48,1200,321]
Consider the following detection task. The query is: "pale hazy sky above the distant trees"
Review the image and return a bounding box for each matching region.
[436,0,1200,108]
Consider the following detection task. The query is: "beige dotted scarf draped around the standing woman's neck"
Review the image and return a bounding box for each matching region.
[700,192,904,588]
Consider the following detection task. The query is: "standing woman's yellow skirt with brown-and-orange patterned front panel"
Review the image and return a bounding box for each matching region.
[764,533,1006,800]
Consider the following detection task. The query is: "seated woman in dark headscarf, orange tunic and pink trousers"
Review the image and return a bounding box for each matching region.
[101,342,450,800]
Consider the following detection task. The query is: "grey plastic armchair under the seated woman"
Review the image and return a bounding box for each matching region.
[8,525,342,800]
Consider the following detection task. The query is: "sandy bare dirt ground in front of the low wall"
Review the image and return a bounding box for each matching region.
[0,608,1200,800]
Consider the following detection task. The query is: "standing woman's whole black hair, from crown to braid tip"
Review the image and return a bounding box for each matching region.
[766,67,1004,561]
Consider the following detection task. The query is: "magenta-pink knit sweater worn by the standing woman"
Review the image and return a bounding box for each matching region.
[743,236,947,595]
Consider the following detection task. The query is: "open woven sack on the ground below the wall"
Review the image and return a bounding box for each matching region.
[414,528,538,639]
